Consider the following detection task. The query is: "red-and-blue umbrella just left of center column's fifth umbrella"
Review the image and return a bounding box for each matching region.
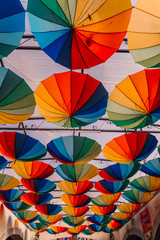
[21,178,56,193]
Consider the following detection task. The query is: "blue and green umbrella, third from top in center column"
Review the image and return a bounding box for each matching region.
[47,136,101,165]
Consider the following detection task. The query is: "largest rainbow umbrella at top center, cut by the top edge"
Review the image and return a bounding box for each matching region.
[28,0,132,69]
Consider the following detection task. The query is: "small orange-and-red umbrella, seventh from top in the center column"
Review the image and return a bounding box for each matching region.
[62,206,89,217]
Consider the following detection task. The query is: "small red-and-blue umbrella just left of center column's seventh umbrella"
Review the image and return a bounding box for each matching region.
[35,203,62,215]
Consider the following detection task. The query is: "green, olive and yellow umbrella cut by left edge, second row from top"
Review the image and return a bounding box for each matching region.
[0,67,36,124]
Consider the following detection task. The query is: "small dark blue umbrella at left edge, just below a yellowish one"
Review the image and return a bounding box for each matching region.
[0,189,24,203]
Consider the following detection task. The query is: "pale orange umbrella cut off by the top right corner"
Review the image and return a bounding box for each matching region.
[127,0,160,68]
